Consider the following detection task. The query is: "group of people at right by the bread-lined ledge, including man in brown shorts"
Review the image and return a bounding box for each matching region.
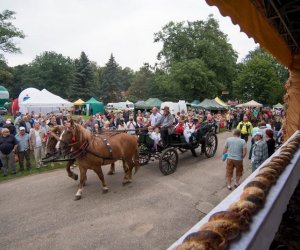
[223,109,284,190]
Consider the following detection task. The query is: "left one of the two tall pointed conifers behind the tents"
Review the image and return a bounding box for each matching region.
[71,51,94,101]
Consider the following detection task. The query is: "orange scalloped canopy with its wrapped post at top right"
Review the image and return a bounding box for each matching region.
[206,0,300,139]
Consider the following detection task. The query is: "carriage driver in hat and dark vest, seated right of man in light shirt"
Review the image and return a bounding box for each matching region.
[153,106,175,146]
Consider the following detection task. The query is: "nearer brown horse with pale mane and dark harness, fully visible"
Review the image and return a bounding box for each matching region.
[59,121,139,200]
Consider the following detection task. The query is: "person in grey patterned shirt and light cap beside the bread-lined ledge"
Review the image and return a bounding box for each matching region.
[251,131,268,172]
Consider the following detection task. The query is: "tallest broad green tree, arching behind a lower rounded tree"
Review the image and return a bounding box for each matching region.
[154,16,237,96]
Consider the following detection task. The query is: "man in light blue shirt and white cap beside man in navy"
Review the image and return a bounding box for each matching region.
[15,127,31,172]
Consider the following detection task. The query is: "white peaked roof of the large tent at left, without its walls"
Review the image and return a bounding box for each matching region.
[22,89,73,107]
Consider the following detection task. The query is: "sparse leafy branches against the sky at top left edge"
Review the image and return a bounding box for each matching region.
[0,10,25,58]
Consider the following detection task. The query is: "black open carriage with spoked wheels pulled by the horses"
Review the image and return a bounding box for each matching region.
[138,124,218,175]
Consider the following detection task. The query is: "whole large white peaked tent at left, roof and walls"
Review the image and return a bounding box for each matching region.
[22,89,73,114]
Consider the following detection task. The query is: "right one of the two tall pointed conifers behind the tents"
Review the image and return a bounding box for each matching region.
[101,54,122,103]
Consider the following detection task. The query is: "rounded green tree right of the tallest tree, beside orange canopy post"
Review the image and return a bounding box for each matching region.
[234,48,288,105]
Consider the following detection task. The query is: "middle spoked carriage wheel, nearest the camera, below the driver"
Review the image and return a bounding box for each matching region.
[159,148,178,175]
